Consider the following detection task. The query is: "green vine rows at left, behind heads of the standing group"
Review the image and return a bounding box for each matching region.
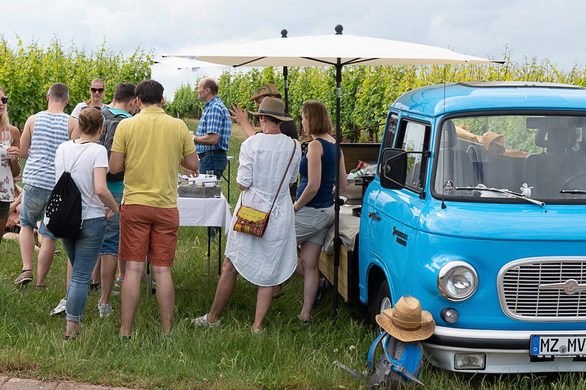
[0,36,153,128]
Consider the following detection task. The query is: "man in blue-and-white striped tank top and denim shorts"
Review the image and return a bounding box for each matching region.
[14,83,77,288]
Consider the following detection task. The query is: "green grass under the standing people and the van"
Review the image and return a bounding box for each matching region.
[0,123,586,390]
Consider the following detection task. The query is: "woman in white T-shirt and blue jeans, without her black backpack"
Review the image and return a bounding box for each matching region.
[55,108,119,339]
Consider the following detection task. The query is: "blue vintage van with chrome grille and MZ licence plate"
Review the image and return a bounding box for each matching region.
[357,82,586,373]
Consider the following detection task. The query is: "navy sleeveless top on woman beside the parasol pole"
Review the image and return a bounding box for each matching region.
[297,138,336,209]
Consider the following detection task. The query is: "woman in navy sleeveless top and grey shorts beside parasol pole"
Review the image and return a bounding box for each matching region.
[293,102,347,326]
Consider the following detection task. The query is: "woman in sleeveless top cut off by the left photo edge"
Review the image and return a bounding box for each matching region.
[0,87,20,241]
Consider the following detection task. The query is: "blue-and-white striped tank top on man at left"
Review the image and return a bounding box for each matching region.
[22,111,69,190]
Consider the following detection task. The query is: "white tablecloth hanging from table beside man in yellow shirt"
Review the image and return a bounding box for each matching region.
[177,194,232,228]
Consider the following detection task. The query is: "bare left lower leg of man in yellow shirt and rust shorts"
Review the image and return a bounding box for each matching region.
[120,261,145,336]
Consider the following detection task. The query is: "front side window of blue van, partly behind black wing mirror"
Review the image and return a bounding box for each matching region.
[395,121,430,192]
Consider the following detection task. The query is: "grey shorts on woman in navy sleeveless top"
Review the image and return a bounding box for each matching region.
[295,206,334,245]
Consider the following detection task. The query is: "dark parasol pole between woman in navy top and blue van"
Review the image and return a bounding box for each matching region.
[332,58,342,320]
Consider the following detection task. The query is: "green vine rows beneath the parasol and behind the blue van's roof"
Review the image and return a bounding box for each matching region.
[173,48,586,142]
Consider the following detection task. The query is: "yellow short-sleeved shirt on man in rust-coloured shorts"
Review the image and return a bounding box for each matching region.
[112,108,195,208]
